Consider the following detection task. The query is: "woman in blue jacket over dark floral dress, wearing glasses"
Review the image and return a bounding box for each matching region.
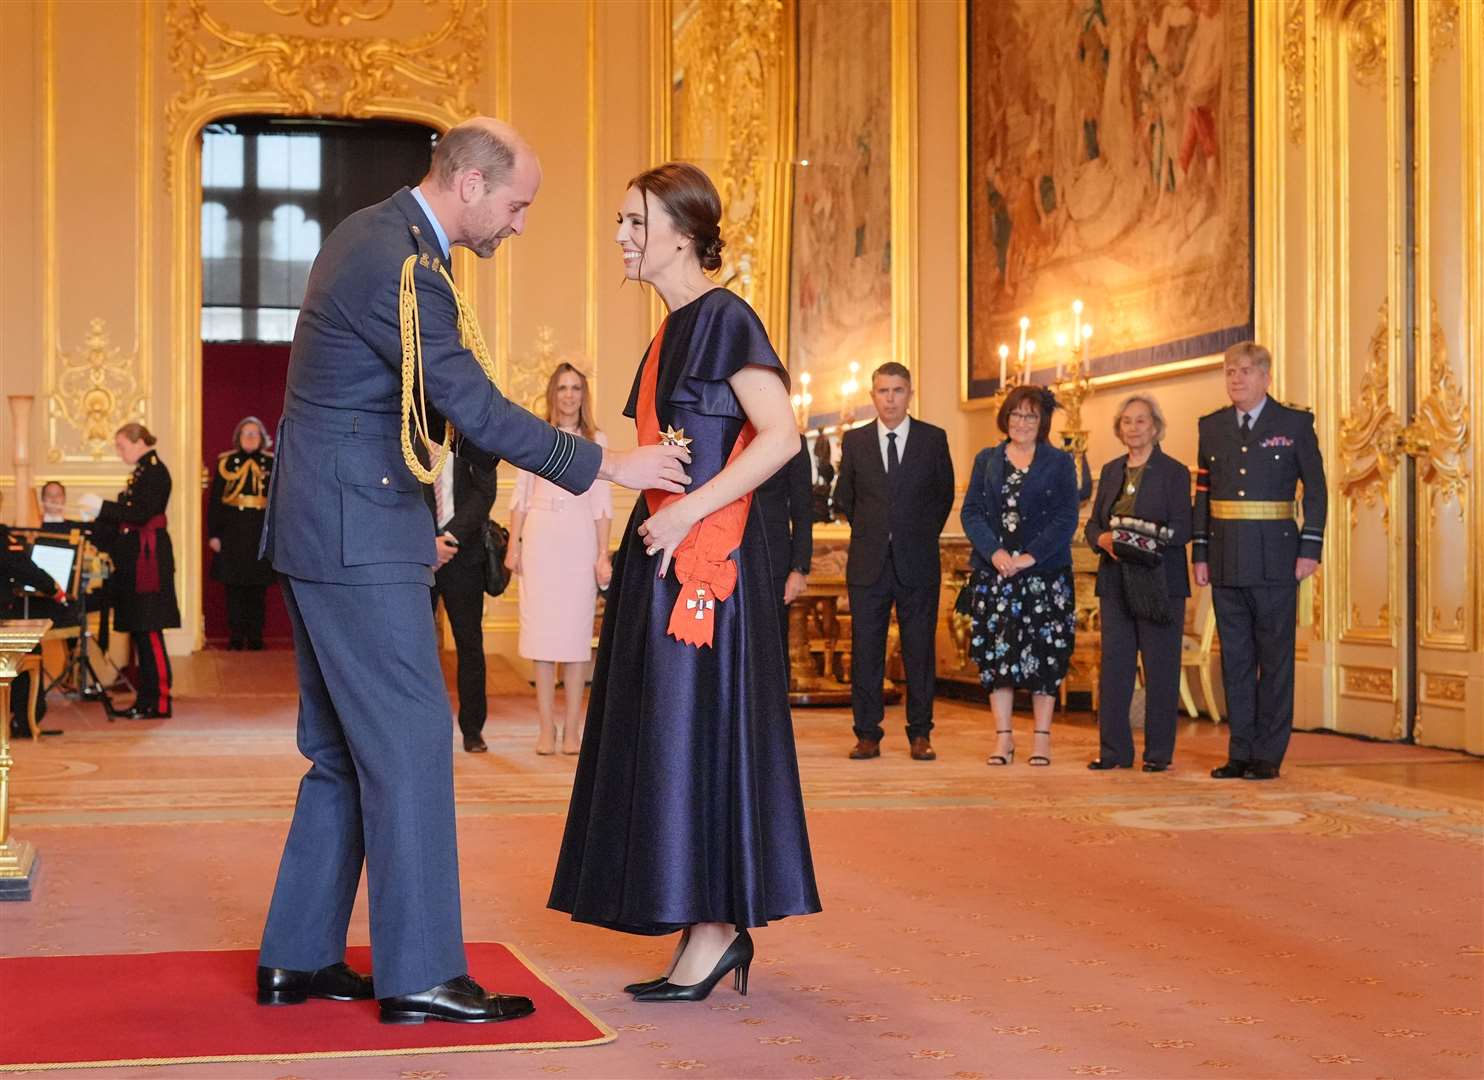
[960,386,1079,765]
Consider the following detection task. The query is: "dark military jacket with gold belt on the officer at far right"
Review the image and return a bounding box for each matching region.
[1190,398,1328,586]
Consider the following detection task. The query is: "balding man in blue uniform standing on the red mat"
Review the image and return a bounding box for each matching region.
[258,117,689,1024]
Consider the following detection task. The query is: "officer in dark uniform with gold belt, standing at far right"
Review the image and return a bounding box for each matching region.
[1190,341,1328,780]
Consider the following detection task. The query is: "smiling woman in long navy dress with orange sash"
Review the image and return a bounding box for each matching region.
[551,163,819,1001]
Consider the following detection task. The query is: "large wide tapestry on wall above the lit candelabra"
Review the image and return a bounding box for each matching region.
[965,0,1252,399]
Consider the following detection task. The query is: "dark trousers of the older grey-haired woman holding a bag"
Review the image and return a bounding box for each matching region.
[1098,587,1186,765]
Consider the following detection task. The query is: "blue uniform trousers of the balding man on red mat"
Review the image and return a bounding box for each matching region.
[260,577,467,997]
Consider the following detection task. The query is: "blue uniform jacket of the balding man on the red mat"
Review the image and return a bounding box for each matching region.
[263,187,603,585]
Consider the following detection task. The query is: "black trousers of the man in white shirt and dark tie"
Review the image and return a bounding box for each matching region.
[849,547,939,740]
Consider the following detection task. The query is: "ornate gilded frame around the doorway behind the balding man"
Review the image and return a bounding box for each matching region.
[165,0,492,650]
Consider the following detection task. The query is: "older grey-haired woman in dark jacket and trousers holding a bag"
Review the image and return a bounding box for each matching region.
[1086,393,1190,773]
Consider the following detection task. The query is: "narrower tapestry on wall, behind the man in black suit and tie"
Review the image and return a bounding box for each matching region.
[788,0,898,424]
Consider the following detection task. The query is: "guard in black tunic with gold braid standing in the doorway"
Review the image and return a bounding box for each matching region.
[206,417,273,650]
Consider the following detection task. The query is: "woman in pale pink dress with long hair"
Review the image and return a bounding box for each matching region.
[505,363,613,754]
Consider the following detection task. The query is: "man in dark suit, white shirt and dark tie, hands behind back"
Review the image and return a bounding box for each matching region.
[834,362,953,761]
